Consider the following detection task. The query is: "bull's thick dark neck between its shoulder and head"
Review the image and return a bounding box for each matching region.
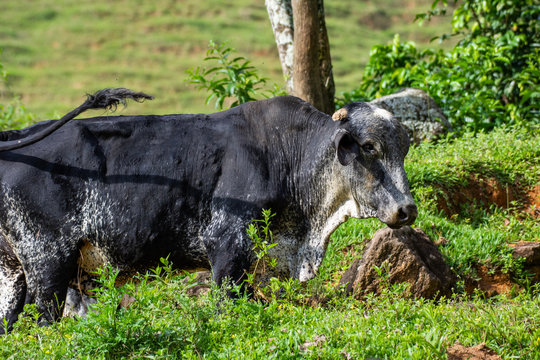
[247,98,348,228]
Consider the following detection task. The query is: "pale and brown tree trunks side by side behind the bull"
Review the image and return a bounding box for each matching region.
[265,0,335,114]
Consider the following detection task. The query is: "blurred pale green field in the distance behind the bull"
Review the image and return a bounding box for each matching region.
[0,0,456,120]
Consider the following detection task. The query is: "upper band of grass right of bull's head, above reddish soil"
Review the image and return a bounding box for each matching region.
[405,126,540,193]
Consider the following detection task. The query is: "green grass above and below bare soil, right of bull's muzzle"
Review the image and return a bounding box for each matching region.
[405,127,540,272]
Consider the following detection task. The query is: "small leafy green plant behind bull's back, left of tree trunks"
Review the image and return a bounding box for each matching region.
[186,41,284,110]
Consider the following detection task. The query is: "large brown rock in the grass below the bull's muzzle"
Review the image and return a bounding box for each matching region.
[340,226,457,299]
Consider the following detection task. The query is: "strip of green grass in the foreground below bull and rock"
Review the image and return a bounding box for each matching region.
[0,262,540,359]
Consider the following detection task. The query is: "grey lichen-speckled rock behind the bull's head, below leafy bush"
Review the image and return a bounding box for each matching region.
[371,88,452,144]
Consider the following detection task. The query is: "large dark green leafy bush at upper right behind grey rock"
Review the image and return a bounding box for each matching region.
[338,0,540,132]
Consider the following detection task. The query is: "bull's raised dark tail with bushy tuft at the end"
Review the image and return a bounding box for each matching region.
[0,88,154,151]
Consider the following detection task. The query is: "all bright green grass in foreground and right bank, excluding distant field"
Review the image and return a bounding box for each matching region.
[0,124,540,359]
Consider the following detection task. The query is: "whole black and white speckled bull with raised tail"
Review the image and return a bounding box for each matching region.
[0,89,417,325]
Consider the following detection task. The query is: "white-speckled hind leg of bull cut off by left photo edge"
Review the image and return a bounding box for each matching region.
[0,237,26,334]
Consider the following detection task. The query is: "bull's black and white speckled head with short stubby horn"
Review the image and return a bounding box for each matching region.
[332,103,417,228]
